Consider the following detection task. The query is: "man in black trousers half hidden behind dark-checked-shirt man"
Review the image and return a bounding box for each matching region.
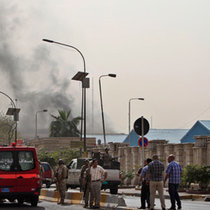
[139,158,152,209]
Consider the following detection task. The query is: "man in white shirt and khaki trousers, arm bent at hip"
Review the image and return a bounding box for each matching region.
[90,159,107,209]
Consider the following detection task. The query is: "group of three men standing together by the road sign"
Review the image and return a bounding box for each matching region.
[138,154,182,210]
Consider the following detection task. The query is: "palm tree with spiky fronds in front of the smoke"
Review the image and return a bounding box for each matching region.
[50,110,81,137]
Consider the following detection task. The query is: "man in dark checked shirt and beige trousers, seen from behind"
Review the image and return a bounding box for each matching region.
[146,155,166,210]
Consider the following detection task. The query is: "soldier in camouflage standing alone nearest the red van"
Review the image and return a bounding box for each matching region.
[55,159,68,204]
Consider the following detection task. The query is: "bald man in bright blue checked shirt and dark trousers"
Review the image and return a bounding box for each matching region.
[164,154,182,210]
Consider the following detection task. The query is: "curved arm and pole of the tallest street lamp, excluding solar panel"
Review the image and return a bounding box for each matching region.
[42,39,87,152]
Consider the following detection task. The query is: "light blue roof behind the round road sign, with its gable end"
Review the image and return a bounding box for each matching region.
[123,129,188,146]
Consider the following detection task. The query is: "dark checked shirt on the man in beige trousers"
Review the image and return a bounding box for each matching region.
[147,160,164,182]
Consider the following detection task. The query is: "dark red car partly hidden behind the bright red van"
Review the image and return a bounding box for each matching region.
[40,162,55,188]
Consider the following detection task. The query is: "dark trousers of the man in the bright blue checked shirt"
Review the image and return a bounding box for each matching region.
[168,183,181,209]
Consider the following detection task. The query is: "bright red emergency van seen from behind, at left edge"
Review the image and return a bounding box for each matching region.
[0,143,41,206]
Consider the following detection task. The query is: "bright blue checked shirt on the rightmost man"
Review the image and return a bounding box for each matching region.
[166,161,182,184]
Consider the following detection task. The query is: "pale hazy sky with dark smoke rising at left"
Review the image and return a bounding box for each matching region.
[0,0,210,139]
